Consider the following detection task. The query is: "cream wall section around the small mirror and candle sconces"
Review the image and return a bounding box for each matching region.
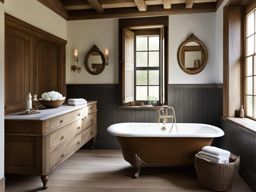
[66,19,119,84]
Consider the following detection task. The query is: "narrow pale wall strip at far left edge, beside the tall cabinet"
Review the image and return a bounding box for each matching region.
[0,2,4,180]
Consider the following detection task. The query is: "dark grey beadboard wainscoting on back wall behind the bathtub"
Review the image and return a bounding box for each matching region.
[67,84,222,149]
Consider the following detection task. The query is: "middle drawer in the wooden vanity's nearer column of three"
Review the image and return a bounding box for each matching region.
[50,120,82,152]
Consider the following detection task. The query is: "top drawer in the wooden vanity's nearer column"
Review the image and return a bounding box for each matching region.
[49,109,82,130]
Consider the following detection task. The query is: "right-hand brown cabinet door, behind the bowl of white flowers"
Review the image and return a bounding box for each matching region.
[35,39,61,97]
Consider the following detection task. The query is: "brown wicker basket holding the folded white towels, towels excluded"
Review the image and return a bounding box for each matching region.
[195,152,240,191]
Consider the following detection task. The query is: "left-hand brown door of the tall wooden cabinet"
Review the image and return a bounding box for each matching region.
[5,26,32,113]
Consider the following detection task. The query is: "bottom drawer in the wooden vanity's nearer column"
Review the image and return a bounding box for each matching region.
[50,135,81,168]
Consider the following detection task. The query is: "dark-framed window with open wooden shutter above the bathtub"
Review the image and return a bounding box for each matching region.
[119,17,168,105]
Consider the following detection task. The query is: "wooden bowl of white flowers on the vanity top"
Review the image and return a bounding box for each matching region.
[39,91,66,108]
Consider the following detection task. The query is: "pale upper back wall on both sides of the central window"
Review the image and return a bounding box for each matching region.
[66,13,218,84]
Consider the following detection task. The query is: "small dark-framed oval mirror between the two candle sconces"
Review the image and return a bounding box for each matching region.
[84,45,106,75]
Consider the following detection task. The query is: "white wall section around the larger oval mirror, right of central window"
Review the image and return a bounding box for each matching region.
[169,13,217,84]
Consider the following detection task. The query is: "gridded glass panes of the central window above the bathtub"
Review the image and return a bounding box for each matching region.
[135,35,160,101]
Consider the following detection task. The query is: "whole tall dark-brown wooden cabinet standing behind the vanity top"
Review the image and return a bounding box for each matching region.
[5,14,67,114]
